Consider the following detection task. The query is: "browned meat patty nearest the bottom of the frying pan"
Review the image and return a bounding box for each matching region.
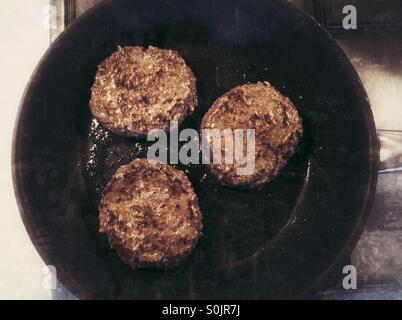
[99,159,202,268]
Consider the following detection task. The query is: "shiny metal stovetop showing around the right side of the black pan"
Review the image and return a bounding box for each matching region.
[52,0,402,299]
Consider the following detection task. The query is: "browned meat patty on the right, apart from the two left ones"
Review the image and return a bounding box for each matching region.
[201,82,303,188]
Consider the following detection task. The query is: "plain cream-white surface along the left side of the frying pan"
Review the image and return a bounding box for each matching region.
[0,0,51,299]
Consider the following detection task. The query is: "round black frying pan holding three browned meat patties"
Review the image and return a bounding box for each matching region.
[13,0,378,299]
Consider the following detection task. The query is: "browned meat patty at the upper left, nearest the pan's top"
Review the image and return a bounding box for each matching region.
[90,47,197,137]
